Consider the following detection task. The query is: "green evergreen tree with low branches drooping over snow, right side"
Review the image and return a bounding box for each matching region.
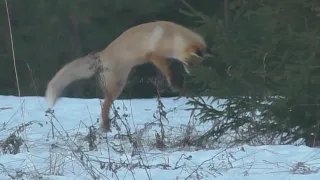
[185,0,320,146]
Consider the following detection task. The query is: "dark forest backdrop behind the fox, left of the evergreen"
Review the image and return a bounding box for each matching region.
[0,0,221,98]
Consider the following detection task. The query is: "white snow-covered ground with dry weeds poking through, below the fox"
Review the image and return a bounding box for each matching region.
[0,96,320,180]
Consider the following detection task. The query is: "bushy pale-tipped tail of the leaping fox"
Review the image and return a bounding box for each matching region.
[45,54,99,108]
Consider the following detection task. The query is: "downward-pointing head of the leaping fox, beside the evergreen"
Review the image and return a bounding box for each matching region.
[179,44,213,74]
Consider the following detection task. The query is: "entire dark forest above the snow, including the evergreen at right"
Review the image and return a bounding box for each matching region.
[0,0,320,146]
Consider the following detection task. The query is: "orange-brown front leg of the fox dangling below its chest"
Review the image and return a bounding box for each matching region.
[148,54,181,91]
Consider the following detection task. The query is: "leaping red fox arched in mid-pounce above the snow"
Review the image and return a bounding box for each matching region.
[45,21,212,131]
